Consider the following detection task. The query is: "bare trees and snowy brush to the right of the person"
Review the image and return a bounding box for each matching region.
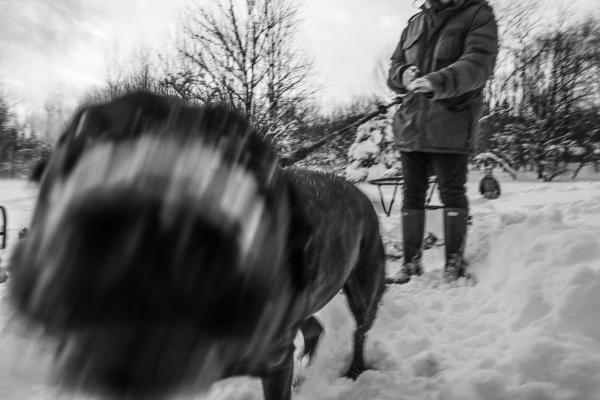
[480,2,600,175]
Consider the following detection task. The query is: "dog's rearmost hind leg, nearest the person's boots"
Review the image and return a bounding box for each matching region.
[344,235,385,379]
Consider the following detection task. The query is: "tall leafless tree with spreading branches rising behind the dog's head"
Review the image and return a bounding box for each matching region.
[165,0,313,132]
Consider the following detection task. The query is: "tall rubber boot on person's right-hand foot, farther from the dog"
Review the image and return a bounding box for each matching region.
[444,208,469,282]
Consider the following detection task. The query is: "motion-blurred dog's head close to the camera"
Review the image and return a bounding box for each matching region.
[11,93,293,397]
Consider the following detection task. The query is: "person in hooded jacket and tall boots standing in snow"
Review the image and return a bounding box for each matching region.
[388,0,498,283]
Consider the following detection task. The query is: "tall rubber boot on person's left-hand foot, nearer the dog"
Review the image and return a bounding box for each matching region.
[388,210,425,284]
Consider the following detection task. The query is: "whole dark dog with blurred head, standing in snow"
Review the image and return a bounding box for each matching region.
[11,93,385,400]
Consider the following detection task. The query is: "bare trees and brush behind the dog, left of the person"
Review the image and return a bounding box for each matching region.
[0,0,356,176]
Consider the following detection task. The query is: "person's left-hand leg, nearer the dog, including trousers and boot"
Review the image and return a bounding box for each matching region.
[388,152,429,283]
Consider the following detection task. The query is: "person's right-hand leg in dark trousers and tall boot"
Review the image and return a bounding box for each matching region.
[433,154,469,280]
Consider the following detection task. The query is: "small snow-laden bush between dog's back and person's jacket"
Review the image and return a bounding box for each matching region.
[346,112,401,182]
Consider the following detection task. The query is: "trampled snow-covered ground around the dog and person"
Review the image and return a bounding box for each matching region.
[0,172,600,400]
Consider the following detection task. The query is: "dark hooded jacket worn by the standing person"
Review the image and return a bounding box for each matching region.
[388,0,498,154]
